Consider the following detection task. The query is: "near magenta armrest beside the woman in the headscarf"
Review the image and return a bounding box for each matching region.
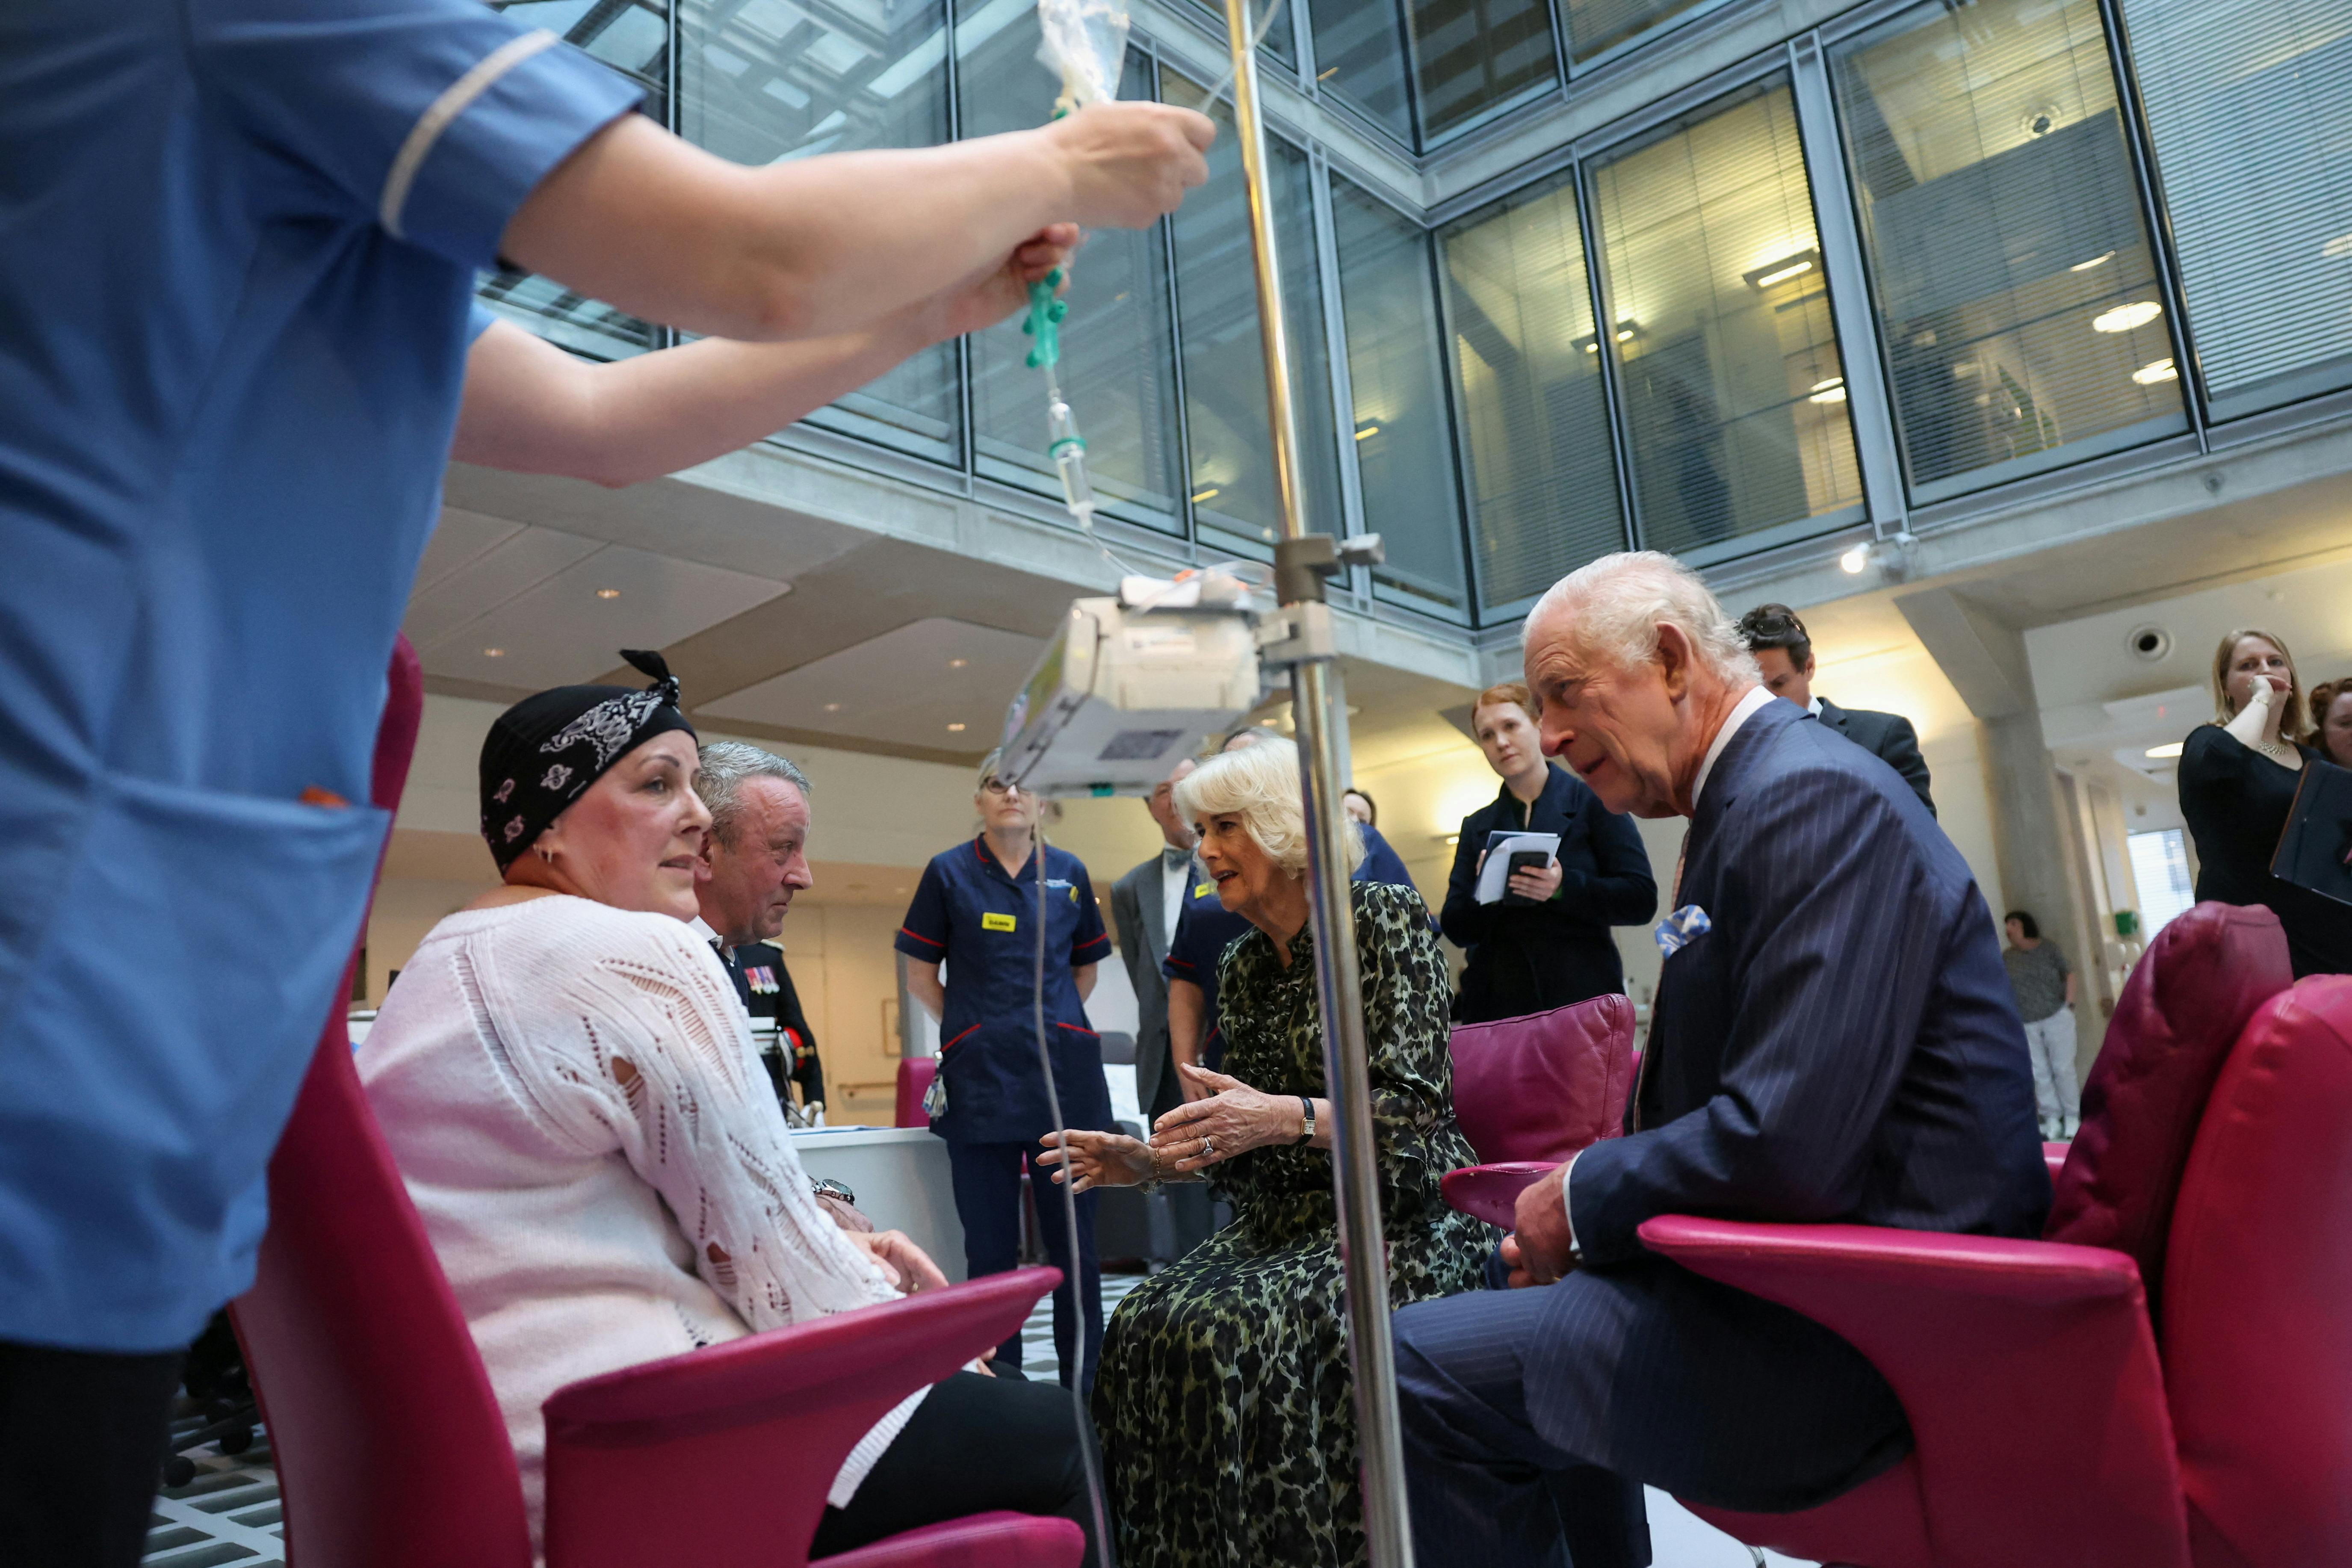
[546,1270,1061,1568]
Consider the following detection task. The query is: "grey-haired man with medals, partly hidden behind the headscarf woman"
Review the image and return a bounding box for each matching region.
[694,741,826,1105]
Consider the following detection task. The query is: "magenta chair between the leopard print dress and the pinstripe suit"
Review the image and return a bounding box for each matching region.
[1439,992,1632,1229]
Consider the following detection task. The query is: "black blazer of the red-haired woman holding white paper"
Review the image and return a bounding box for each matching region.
[1439,766,1658,1023]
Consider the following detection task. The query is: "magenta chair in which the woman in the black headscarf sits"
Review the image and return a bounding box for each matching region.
[230,642,1084,1568]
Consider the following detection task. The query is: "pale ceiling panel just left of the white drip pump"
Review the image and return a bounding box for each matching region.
[696,616,1044,752]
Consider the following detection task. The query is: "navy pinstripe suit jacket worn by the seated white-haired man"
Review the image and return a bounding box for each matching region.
[1569,703,2051,1262]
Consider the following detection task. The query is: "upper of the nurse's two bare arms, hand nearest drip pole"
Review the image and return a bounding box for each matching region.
[499,103,1216,341]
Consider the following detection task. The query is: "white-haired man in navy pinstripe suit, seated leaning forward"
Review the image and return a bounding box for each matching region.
[1397,552,2051,1568]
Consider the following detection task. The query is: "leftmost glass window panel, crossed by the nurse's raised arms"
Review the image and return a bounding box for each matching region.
[480,0,671,360]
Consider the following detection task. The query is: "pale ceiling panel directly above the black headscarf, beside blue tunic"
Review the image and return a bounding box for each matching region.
[402,508,793,689]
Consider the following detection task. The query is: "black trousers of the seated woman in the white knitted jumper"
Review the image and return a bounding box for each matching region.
[809,1373,1103,1568]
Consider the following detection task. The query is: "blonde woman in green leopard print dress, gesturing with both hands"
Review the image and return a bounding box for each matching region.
[1047,745,1491,1568]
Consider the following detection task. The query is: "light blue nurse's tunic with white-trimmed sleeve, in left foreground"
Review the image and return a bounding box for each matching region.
[0,0,638,1352]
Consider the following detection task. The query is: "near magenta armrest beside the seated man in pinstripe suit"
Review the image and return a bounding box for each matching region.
[1642,1215,2187,1568]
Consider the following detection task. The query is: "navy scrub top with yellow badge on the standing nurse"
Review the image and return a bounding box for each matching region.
[898,837,1110,1143]
